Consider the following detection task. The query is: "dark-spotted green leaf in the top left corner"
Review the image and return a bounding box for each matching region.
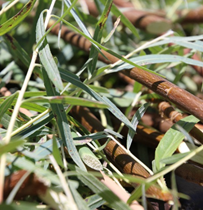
[0,0,36,36]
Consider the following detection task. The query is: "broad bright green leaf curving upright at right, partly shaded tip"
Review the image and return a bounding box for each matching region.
[155,115,199,170]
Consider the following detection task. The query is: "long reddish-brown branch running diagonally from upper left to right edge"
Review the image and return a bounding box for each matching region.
[48,21,203,122]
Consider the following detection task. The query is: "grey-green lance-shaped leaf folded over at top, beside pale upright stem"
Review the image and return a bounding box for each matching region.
[36,12,63,90]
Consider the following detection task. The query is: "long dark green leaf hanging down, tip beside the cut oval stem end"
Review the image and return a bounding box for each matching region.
[43,69,86,170]
